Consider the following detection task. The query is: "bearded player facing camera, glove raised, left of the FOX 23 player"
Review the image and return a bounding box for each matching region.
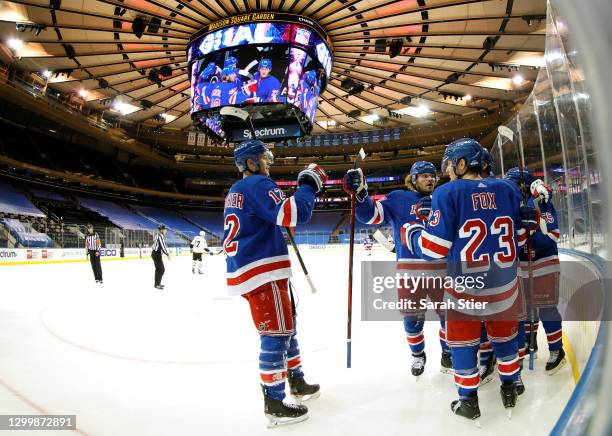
[344,161,452,377]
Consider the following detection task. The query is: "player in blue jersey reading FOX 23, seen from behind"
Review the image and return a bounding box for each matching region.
[404,138,536,419]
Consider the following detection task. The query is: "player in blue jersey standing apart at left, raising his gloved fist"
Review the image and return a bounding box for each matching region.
[223,139,327,426]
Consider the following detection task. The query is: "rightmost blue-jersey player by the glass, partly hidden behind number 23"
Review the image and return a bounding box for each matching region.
[505,168,566,375]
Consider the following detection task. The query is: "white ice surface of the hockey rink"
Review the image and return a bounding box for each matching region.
[0,250,573,436]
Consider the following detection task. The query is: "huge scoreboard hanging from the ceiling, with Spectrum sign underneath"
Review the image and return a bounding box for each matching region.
[187,12,333,141]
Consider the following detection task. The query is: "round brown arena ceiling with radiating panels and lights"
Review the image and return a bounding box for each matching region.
[0,0,546,133]
